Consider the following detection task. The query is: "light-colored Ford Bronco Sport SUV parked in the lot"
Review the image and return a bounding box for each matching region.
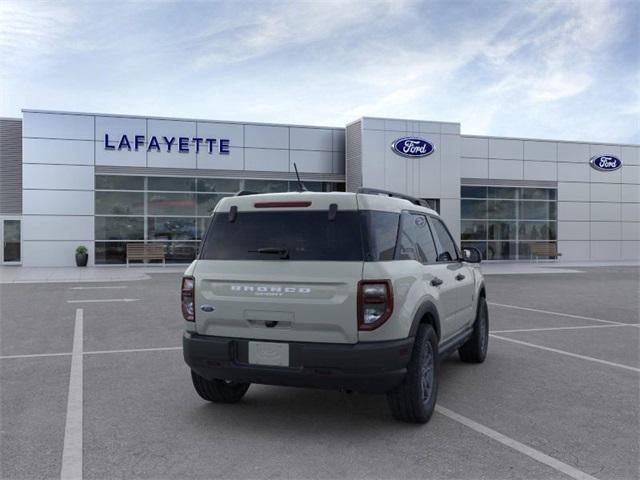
[182,190,489,423]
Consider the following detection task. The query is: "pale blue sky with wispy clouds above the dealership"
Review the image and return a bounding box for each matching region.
[0,0,640,143]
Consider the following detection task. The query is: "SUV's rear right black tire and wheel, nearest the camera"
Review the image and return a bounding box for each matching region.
[387,324,438,423]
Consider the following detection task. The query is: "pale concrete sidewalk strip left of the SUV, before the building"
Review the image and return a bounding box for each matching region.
[0,265,187,284]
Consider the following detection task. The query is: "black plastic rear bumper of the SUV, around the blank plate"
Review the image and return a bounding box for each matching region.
[182,332,413,393]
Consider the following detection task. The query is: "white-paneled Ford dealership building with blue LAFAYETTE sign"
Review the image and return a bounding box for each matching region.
[0,110,640,266]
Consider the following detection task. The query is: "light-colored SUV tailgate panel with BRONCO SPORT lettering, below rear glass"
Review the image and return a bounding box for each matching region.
[194,260,362,343]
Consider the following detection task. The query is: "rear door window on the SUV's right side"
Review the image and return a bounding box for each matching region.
[396,212,436,263]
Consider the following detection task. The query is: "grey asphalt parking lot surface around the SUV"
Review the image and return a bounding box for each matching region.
[0,267,640,480]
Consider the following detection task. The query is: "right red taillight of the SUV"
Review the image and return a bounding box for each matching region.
[358,280,393,330]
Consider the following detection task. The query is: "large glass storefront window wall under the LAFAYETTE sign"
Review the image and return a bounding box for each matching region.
[95,175,345,264]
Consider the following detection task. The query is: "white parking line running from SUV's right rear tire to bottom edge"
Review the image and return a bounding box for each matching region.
[436,405,597,480]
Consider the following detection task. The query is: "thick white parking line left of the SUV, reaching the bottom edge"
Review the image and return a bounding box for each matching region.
[60,308,83,480]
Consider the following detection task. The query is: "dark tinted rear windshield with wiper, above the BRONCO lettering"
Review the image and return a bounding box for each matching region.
[200,210,363,261]
